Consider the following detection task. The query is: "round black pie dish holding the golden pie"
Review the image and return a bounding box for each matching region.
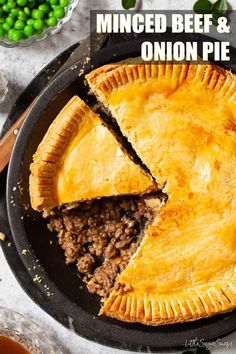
[7,36,236,352]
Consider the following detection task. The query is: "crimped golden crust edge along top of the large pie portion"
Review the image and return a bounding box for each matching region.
[86,63,235,99]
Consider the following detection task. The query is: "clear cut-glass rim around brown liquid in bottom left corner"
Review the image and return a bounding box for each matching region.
[0,307,62,354]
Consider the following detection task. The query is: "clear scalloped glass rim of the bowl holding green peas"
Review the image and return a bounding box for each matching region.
[0,0,78,48]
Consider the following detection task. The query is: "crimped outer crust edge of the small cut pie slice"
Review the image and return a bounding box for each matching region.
[29,97,83,211]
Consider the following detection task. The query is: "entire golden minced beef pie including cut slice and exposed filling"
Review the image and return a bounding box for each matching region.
[30,63,236,325]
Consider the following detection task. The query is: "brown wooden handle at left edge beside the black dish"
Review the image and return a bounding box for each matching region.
[0,104,32,173]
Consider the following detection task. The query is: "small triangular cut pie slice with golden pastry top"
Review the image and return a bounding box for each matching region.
[30,97,156,211]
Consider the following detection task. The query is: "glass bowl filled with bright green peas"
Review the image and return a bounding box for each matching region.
[0,0,78,47]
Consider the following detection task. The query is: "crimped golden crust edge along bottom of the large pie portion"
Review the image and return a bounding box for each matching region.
[100,282,236,326]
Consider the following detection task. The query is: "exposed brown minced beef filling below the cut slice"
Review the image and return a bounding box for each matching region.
[49,197,156,296]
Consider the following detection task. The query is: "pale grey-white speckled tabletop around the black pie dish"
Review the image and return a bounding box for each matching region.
[0,0,236,354]
